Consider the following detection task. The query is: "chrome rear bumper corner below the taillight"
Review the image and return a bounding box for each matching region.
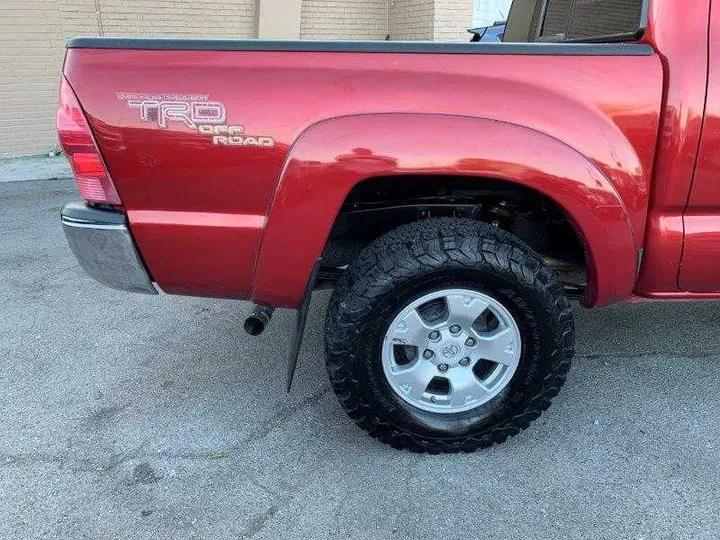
[60,203,157,294]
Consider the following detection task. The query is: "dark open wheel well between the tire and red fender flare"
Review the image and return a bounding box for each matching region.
[319,175,588,296]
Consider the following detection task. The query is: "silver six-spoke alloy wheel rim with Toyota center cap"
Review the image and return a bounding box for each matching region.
[382,289,522,414]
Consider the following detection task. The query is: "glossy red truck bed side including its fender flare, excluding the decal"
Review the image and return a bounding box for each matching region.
[65,49,663,307]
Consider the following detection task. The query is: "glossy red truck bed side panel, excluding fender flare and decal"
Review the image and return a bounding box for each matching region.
[65,43,662,303]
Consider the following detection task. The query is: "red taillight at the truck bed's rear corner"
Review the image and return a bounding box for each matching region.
[57,77,121,204]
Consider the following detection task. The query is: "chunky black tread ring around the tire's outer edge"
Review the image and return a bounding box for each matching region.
[326,218,574,454]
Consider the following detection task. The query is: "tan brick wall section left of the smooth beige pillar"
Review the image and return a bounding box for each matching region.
[0,0,256,158]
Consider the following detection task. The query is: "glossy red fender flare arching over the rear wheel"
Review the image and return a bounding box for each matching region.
[252,113,637,308]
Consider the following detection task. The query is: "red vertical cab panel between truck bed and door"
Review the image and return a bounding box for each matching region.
[635,0,710,296]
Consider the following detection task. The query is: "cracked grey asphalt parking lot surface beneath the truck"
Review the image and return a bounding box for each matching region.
[0,180,720,540]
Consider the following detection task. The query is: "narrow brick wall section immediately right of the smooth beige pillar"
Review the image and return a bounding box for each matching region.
[300,0,388,39]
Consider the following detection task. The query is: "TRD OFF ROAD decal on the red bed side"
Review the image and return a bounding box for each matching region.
[117,92,275,148]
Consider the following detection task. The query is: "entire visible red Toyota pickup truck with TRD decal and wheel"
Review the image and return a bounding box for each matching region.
[58,0,720,452]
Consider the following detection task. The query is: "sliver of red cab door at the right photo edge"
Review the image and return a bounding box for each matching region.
[679,2,720,293]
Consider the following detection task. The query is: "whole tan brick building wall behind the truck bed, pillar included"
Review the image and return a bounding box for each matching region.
[0,0,480,158]
